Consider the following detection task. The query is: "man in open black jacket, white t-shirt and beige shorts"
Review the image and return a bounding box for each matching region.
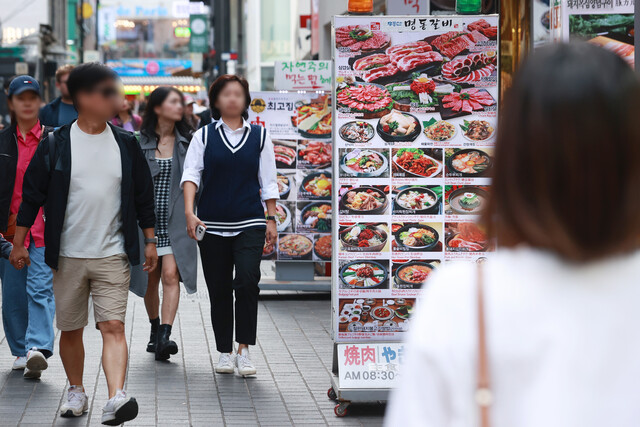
[10,63,158,425]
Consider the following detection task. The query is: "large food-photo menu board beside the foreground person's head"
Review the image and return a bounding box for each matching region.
[333,15,498,342]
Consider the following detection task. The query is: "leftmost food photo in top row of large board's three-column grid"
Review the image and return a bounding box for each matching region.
[338,148,389,178]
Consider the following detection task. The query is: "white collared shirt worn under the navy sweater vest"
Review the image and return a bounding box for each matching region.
[180,119,280,237]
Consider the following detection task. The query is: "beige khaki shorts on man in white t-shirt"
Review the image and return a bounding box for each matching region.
[53,254,131,331]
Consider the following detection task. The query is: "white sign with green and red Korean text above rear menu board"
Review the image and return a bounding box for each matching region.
[274,61,331,91]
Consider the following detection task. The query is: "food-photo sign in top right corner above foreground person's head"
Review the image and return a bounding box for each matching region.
[551,0,635,67]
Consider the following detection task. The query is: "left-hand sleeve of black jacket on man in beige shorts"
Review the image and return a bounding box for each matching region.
[16,144,50,227]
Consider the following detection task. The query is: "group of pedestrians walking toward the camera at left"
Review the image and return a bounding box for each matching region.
[0,63,279,425]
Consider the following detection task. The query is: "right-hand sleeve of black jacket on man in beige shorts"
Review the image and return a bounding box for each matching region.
[131,140,156,229]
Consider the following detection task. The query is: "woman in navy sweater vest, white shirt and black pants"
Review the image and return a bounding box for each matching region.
[181,74,279,375]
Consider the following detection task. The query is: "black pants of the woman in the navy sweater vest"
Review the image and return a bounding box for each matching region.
[199,228,265,353]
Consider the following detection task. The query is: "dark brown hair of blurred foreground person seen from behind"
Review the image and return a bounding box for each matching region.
[484,43,640,262]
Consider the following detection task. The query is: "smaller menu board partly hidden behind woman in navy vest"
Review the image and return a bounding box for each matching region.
[249,92,332,261]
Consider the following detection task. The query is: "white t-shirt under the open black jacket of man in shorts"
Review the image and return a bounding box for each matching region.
[60,122,125,258]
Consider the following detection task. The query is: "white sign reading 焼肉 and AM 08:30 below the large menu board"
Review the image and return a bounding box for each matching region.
[338,343,404,389]
